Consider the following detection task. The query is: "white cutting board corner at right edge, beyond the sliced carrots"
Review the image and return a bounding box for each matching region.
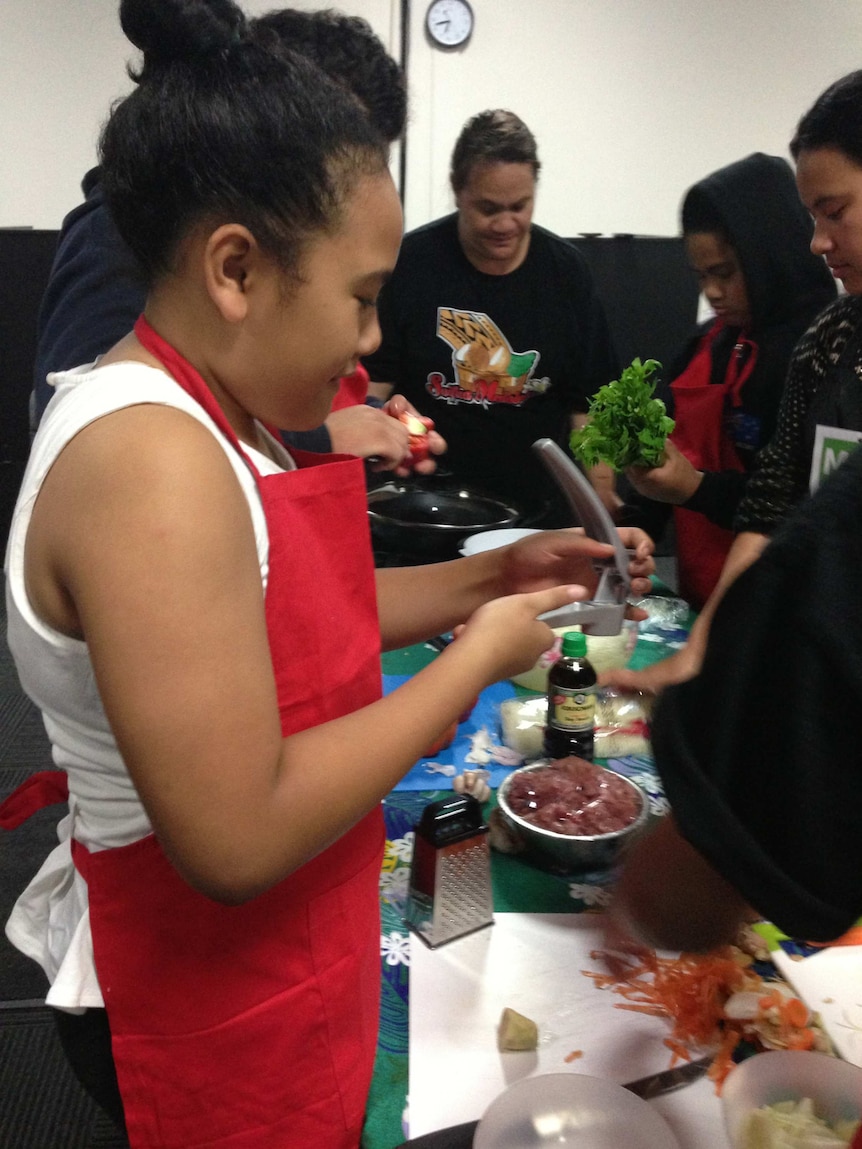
[771,946,862,1065]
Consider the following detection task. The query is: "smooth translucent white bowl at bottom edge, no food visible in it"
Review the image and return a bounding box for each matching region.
[472,1073,679,1149]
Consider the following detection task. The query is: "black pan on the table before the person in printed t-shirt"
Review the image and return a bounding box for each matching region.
[368,477,523,561]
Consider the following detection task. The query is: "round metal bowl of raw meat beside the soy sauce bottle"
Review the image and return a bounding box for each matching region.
[497,758,649,872]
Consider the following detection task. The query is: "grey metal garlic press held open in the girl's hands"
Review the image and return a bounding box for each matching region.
[533,439,631,634]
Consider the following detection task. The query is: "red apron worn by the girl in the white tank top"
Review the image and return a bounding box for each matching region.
[0,317,384,1149]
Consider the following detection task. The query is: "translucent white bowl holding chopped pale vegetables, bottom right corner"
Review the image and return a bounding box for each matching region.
[722,1049,862,1149]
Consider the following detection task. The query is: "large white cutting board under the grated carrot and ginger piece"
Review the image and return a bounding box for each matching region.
[408,913,730,1149]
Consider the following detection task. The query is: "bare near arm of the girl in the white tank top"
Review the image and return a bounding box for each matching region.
[26,404,648,903]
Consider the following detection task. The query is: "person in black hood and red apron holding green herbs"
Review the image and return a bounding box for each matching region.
[628,153,836,608]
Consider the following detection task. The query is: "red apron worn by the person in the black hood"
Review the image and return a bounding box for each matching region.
[670,323,757,610]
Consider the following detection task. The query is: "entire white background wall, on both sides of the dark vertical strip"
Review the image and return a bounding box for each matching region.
[0,0,862,234]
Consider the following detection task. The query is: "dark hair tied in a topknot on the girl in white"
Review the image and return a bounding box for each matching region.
[100,0,387,283]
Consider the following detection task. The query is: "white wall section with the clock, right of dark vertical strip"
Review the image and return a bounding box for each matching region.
[407,0,862,236]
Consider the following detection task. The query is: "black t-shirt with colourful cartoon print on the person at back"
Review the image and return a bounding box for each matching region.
[363,215,618,526]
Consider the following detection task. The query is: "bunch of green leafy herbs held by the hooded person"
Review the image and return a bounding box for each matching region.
[569,358,674,471]
